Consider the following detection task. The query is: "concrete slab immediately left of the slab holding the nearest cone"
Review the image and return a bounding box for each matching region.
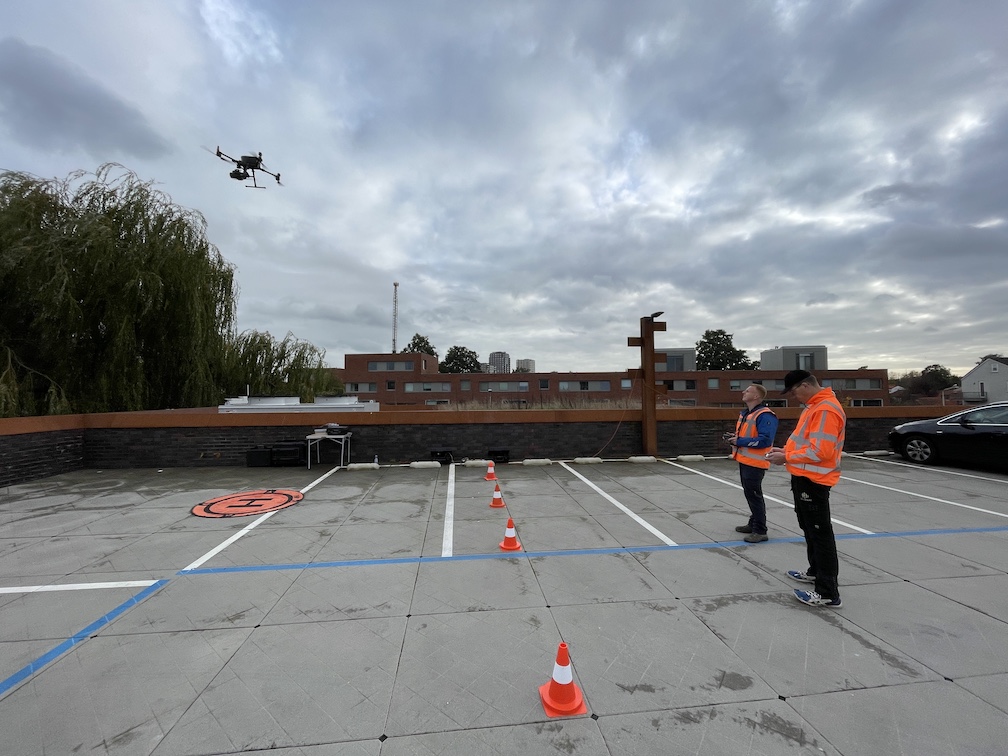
[155,617,405,756]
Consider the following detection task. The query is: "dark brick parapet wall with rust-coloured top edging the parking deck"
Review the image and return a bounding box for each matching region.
[0,407,947,486]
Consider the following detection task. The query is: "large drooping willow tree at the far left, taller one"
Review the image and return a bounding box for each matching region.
[0,163,236,416]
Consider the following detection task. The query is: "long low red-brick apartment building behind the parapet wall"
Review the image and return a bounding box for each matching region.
[333,348,889,409]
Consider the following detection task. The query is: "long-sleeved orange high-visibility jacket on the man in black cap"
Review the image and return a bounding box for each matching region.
[784,388,847,486]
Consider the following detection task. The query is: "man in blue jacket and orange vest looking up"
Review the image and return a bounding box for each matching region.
[728,383,777,543]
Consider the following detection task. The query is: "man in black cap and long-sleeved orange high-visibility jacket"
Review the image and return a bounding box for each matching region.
[766,370,847,609]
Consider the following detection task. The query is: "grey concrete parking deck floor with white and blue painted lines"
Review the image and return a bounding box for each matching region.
[0,457,1008,756]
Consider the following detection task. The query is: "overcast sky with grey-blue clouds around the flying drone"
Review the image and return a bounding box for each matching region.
[0,0,1008,373]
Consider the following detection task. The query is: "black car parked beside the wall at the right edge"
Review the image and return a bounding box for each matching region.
[889,401,1008,468]
